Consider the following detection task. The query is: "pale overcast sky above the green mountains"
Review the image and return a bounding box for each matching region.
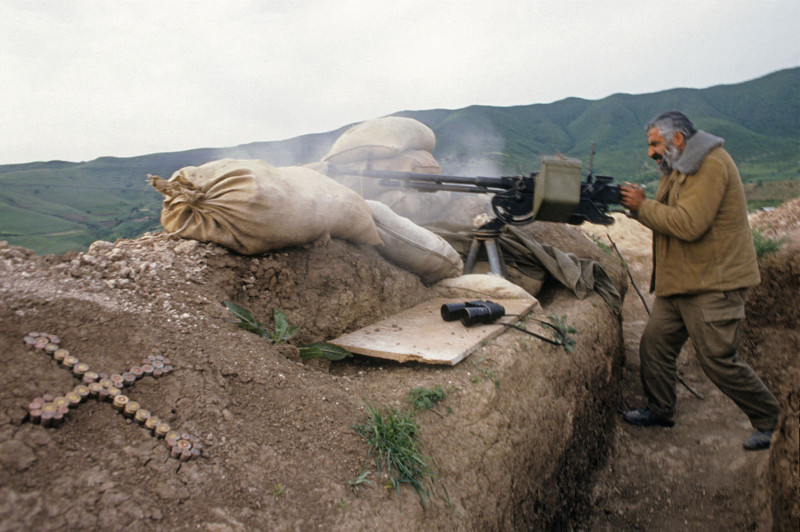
[0,0,800,164]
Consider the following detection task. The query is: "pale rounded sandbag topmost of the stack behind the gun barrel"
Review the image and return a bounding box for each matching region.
[322,116,436,164]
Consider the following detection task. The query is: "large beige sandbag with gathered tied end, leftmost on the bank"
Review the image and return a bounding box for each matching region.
[148,159,381,255]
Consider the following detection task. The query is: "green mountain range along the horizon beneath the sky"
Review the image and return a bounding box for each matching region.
[0,67,800,253]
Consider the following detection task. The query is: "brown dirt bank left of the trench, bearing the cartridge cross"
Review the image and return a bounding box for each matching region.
[0,224,624,530]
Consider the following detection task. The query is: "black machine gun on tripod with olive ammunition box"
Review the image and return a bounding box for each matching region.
[328,156,620,276]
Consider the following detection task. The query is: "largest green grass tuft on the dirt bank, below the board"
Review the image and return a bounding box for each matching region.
[351,403,435,506]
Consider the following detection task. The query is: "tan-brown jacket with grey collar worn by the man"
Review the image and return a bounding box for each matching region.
[638,131,761,296]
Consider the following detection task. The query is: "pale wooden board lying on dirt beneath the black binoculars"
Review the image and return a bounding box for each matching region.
[330,298,538,365]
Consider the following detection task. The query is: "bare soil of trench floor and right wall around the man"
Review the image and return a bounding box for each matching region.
[580,198,800,530]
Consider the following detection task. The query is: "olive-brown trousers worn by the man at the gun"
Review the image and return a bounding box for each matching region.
[639,288,779,430]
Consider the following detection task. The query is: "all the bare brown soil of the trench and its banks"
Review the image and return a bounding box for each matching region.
[0,197,800,530]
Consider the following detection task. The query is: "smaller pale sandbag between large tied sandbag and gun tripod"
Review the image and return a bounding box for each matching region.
[367,200,464,284]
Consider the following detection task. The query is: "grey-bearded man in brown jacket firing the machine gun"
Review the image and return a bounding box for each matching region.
[620,111,778,450]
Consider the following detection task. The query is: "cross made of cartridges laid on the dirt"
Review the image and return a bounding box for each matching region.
[23,332,203,461]
